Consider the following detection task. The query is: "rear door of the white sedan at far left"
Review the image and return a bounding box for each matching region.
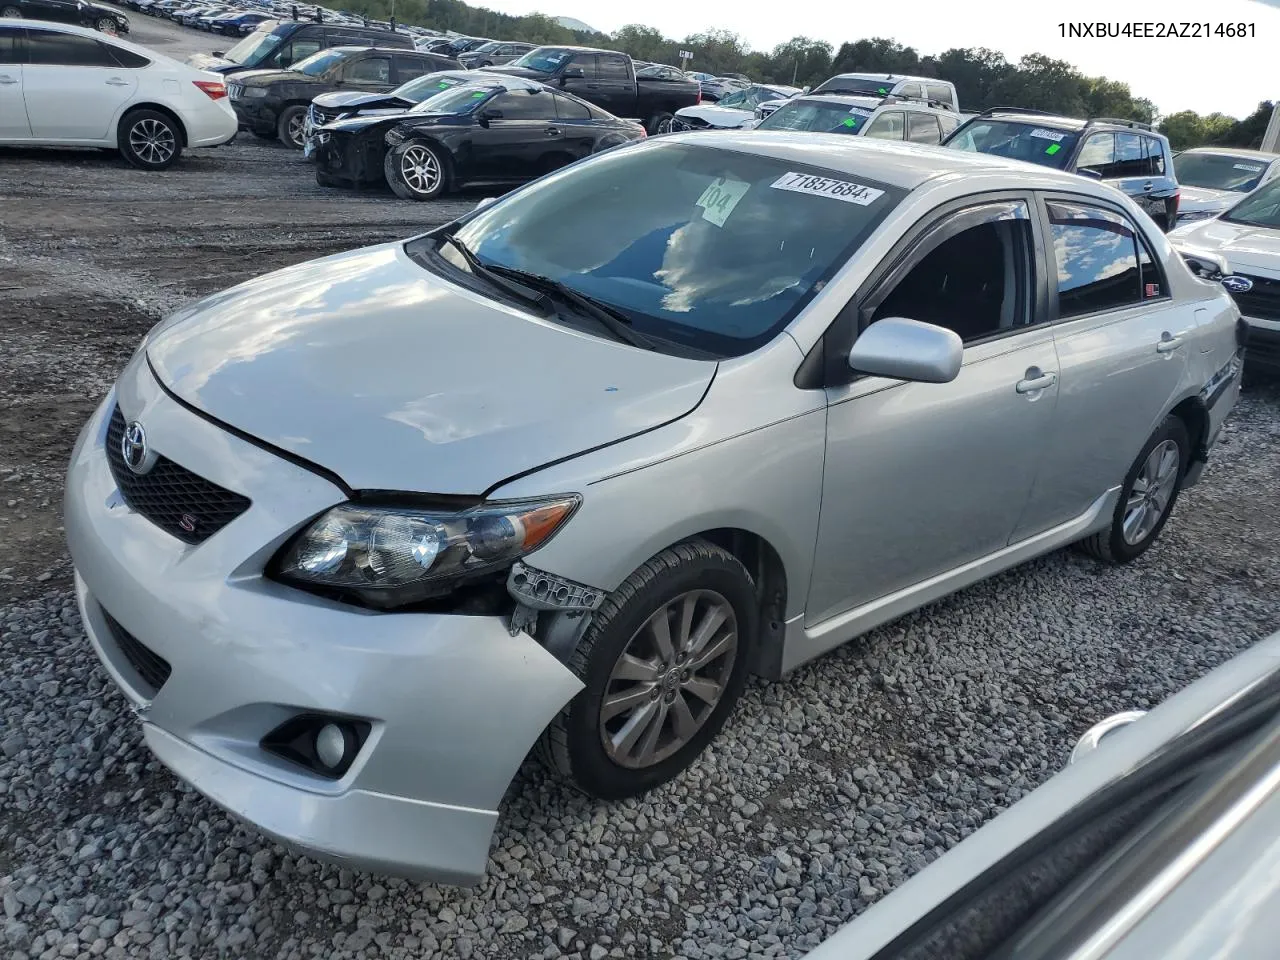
[23,27,138,142]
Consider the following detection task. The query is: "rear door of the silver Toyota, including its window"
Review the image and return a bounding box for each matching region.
[1015,198,1198,538]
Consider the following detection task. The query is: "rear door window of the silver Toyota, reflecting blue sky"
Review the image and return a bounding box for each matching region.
[1047,202,1143,317]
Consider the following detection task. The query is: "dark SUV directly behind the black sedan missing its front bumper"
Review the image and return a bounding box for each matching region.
[227,46,458,150]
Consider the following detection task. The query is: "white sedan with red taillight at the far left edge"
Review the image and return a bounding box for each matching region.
[0,19,237,170]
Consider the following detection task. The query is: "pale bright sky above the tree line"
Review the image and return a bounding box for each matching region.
[481,0,1280,116]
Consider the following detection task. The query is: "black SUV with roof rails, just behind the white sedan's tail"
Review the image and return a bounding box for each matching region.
[186,18,413,74]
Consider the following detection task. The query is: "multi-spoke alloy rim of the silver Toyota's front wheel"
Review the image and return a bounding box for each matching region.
[599,590,737,769]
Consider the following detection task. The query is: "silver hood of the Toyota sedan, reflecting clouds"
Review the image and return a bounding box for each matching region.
[146,243,716,495]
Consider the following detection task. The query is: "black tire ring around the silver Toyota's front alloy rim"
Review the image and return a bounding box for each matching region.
[564,556,758,800]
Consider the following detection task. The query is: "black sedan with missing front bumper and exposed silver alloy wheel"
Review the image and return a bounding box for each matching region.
[315,73,645,200]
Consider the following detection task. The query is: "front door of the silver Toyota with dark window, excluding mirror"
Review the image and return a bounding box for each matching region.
[806,198,1057,626]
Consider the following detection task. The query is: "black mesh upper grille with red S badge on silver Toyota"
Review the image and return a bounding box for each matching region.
[106,407,250,544]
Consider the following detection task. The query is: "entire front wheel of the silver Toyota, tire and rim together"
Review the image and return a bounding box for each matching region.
[539,540,759,800]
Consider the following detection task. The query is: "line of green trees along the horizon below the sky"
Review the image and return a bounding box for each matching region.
[337,0,1272,150]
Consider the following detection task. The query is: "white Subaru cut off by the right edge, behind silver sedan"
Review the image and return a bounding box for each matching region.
[1169,176,1280,375]
